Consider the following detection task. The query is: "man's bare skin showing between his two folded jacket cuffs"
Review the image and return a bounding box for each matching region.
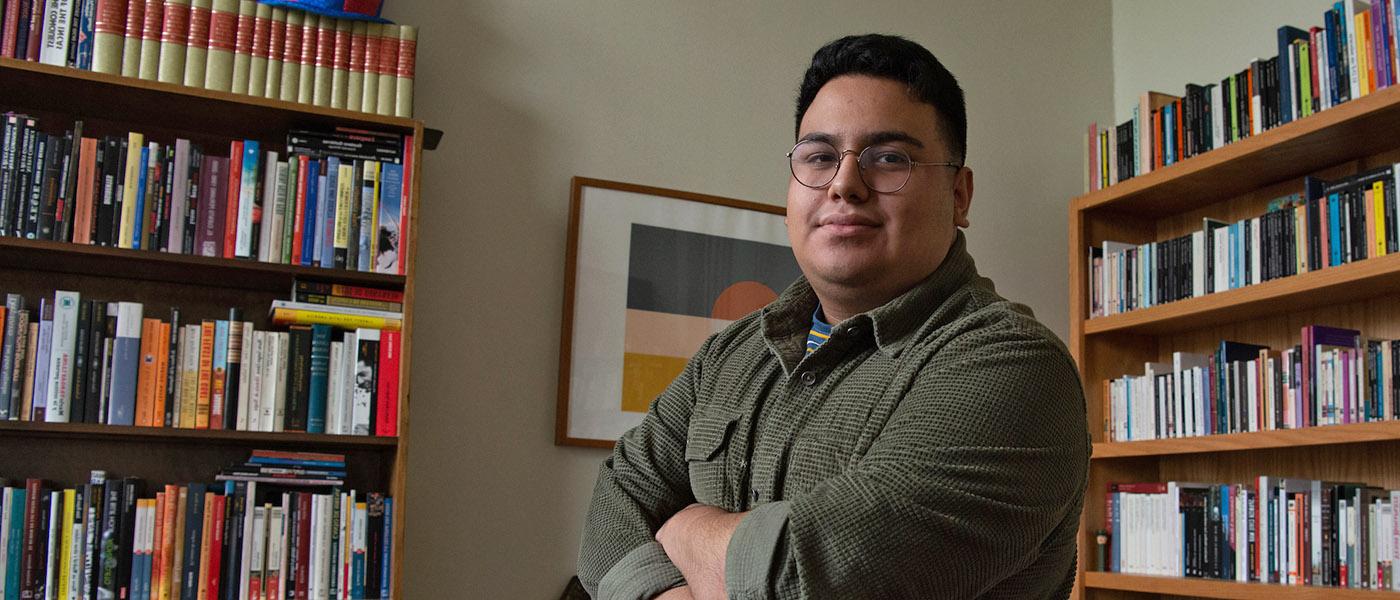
[657,503,748,600]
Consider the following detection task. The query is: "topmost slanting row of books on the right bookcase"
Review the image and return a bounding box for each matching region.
[1085,0,1400,192]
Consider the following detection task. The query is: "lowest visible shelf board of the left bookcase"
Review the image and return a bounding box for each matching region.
[0,421,399,450]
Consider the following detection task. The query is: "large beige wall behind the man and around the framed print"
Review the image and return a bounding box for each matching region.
[385,0,1112,599]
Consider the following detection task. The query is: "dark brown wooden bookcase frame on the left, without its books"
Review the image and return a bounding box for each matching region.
[0,59,422,599]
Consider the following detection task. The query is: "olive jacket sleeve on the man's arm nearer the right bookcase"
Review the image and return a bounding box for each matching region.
[725,334,1089,599]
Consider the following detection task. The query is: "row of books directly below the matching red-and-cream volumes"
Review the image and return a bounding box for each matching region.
[0,113,413,274]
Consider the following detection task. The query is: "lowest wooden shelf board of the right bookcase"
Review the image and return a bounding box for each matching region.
[1084,571,1400,600]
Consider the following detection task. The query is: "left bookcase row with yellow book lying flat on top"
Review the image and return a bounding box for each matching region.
[0,283,402,436]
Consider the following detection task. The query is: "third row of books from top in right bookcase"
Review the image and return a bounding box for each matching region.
[1103,324,1400,442]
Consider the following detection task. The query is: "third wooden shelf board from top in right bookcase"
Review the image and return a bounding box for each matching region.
[1092,421,1400,460]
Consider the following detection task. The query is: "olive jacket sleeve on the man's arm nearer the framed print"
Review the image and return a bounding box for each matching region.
[578,338,713,600]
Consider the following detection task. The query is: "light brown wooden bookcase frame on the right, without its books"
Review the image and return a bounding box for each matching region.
[1068,77,1400,600]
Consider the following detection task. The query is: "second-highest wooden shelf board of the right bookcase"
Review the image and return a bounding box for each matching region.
[1084,255,1400,336]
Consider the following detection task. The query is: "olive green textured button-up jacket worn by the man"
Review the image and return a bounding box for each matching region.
[578,232,1091,600]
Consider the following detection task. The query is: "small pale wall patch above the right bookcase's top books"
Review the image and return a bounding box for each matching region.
[1113,0,1331,123]
